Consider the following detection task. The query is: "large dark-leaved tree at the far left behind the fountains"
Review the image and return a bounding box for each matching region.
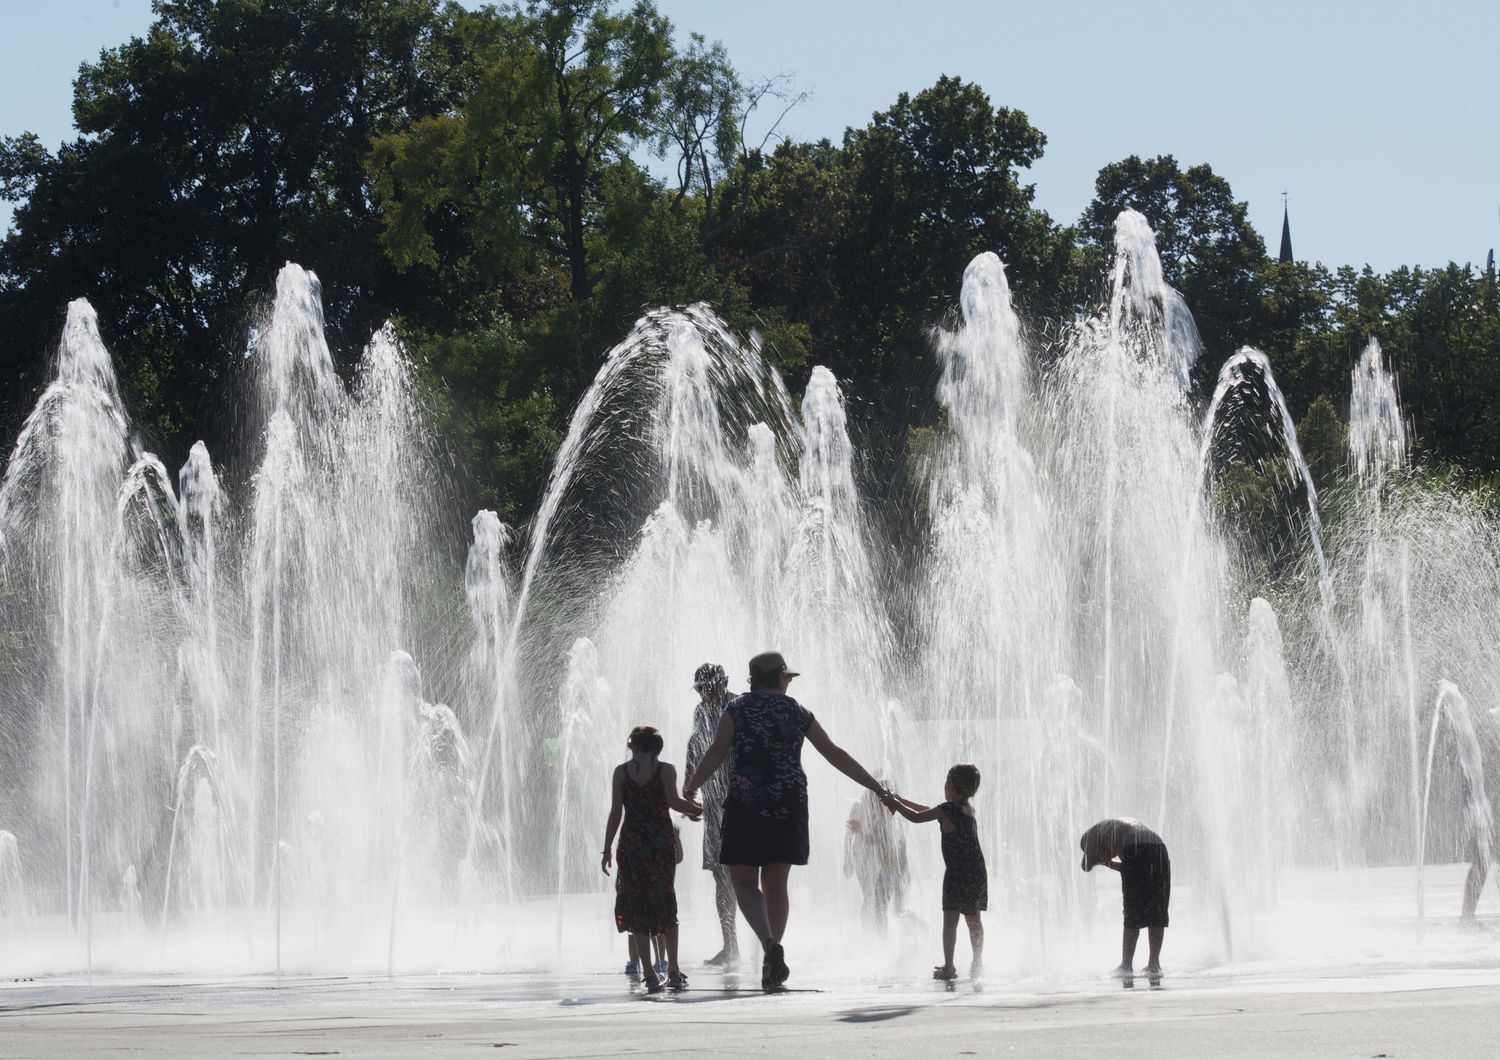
[0,0,480,450]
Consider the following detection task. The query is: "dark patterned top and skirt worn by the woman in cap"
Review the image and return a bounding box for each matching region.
[719,691,813,865]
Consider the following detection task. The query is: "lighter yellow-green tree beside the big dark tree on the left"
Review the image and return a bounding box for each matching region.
[371,0,674,304]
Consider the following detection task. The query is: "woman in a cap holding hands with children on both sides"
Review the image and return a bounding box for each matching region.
[683,652,887,991]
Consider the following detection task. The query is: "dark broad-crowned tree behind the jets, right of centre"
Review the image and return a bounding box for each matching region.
[713,76,1074,404]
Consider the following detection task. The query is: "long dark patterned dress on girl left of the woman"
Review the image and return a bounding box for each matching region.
[615,763,677,934]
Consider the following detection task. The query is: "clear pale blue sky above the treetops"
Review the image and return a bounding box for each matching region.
[0,0,1500,270]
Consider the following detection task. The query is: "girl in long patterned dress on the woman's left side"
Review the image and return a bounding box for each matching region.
[600,726,699,993]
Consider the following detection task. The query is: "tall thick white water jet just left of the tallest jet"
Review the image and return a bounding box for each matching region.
[921,253,1083,925]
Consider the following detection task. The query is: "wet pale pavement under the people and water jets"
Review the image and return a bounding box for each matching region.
[0,865,1500,1057]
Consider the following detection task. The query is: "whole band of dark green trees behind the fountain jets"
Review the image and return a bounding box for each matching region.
[0,0,1500,519]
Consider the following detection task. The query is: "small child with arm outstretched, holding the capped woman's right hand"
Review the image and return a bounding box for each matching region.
[887,765,990,979]
